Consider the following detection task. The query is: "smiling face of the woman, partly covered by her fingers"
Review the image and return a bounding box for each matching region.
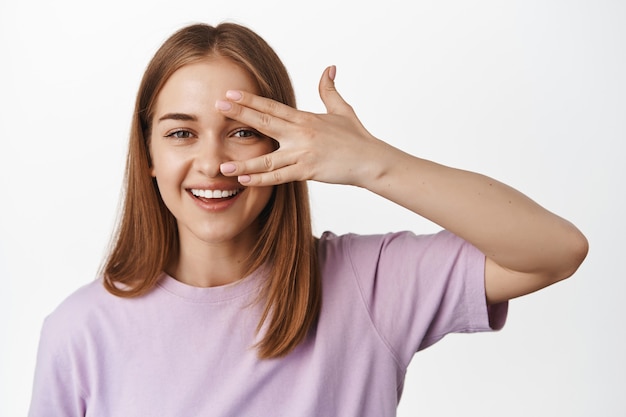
[150,57,274,250]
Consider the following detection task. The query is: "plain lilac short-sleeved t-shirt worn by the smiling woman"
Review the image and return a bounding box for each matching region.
[30,231,507,417]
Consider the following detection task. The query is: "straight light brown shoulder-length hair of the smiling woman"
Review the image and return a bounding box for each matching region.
[102,23,321,358]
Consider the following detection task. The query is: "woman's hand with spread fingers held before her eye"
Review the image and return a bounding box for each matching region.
[216,66,387,186]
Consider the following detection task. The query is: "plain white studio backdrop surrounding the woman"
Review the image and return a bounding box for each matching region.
[0,0,626,417]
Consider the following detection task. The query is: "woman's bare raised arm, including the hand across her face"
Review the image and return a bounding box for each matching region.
[217,67,588,303]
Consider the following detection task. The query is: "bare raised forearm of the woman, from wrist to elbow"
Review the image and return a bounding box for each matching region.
[357,142,586,278]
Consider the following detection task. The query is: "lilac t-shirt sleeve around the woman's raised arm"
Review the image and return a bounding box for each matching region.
[344,230,508,366]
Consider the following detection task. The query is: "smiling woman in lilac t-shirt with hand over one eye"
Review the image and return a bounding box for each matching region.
[30,24,587,417]
